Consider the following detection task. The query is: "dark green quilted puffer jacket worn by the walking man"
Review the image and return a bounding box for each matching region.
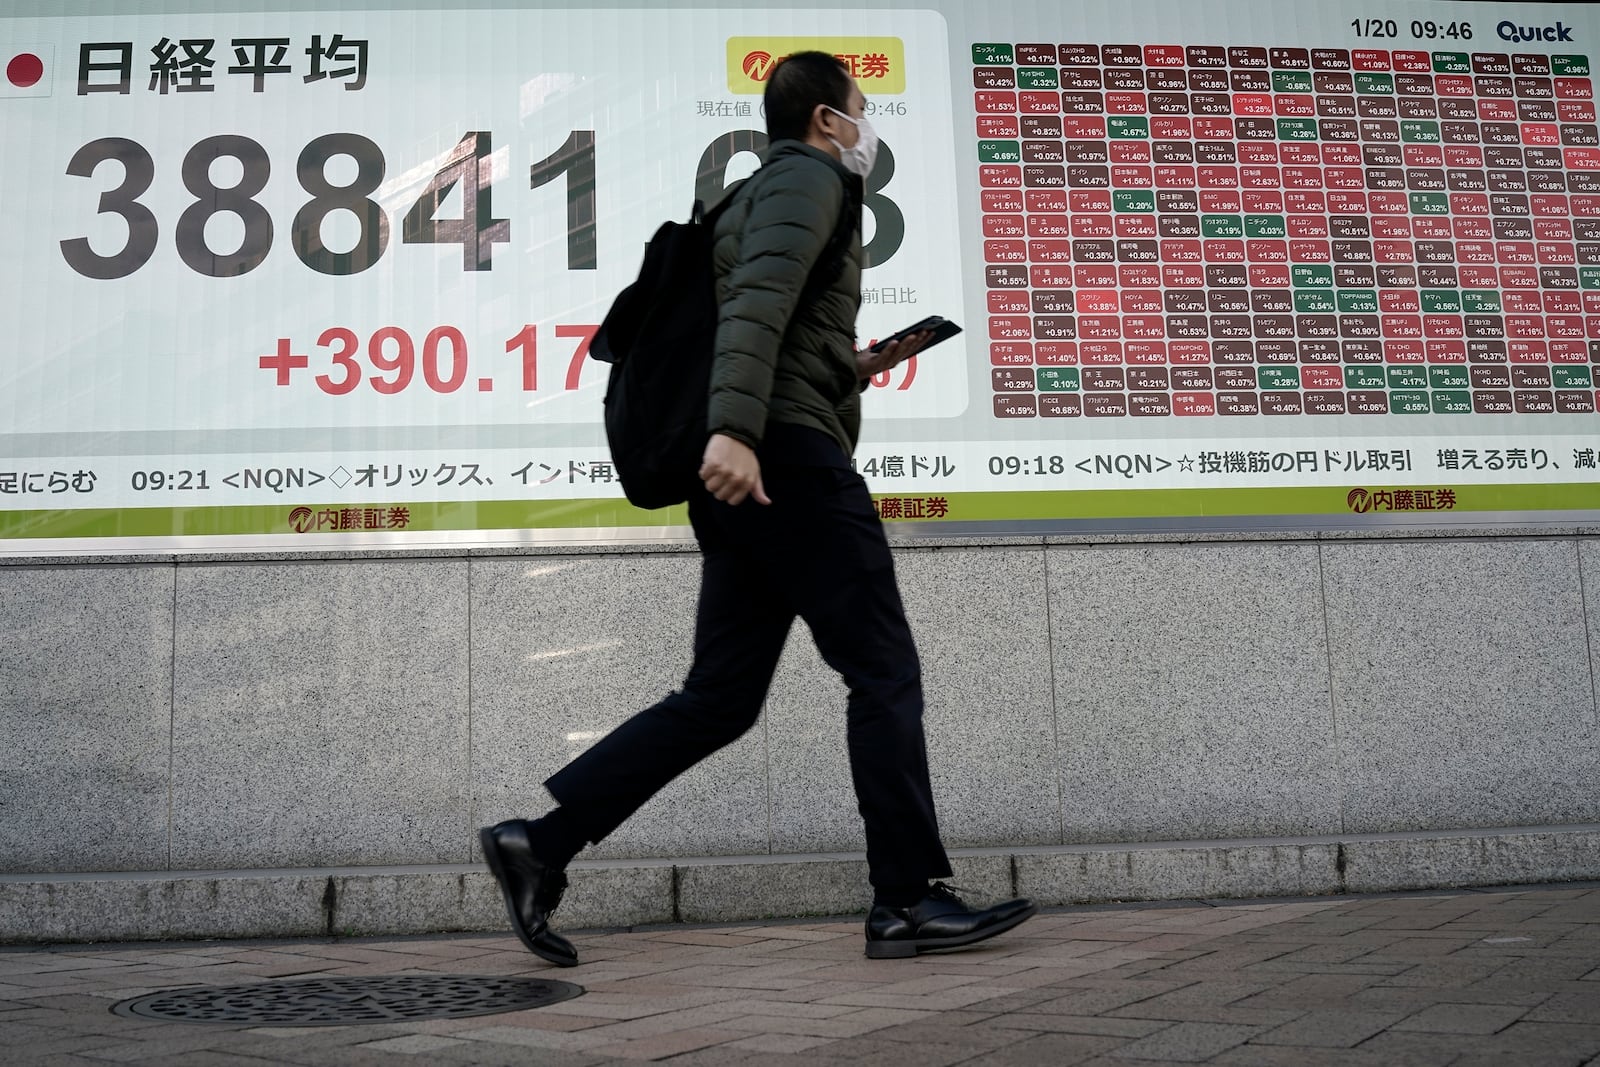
[707,141,861,456]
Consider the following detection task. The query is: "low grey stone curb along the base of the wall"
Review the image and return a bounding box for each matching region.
[0,825,1600,944]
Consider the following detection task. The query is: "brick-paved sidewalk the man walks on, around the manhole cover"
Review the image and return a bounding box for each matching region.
[0,883,1600,1067]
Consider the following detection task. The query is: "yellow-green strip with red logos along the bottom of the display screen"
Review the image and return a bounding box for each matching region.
[9,480,1600,541]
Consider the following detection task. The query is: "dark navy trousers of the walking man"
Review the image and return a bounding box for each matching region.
[546,427,950,891]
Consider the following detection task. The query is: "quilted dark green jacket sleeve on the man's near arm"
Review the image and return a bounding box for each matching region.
[707,158,845,448]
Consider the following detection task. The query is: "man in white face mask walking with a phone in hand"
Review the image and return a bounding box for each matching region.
[478,53,1037,966]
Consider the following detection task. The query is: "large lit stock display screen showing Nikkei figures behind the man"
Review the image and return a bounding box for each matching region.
[0,0,1600,555]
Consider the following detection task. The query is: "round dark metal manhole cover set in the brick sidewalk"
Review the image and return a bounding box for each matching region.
[112,974,584,1027]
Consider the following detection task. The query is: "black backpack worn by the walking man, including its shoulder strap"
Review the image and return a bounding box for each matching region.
[589,181,859,507]
